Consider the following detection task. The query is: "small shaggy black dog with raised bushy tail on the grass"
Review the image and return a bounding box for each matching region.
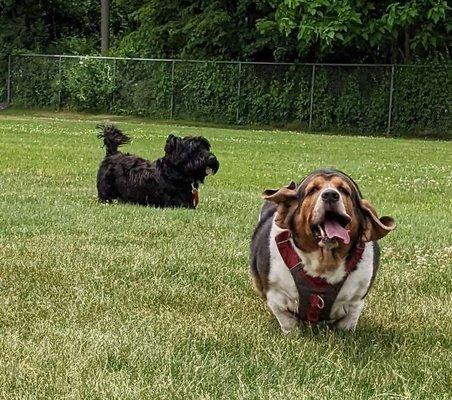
[97,124,220,208]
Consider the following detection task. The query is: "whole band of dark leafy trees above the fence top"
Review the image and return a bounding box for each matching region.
[0,0,452,62]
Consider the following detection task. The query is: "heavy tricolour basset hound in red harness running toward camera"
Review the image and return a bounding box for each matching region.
[250,170,395,333]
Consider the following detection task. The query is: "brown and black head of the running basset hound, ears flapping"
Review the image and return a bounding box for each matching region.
[263,170,395,255]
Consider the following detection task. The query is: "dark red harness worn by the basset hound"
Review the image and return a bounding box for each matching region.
[275,230,368,324]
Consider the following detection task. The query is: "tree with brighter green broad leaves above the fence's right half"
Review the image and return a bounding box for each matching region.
[259,0,452,62]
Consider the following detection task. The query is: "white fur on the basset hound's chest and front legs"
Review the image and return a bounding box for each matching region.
[267,217,374,332]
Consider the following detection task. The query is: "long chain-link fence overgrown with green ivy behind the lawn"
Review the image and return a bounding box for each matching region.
[0,54,452,136]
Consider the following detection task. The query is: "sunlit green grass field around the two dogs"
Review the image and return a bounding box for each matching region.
[0,112,452,400]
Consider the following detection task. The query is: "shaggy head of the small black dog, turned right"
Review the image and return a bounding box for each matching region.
[165,135,220,183]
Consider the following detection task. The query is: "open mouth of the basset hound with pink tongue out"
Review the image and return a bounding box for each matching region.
[311,211,351,244]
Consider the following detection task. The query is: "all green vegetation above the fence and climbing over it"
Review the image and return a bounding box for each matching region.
[0,0,452,134]
